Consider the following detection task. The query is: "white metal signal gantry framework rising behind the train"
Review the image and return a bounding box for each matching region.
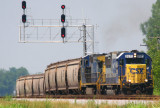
[19,19,94,56]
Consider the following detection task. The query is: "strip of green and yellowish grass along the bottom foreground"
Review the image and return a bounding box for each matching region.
[0,96,160,108]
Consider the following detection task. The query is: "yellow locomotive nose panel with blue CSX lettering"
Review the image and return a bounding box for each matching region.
[125,64,146,84]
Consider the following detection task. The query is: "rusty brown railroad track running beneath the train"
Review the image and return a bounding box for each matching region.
[15,95,160,100]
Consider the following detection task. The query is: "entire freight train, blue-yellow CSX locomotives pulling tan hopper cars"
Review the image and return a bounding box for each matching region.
[16,50,154,97]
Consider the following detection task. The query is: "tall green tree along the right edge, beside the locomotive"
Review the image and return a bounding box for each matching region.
[141,0,160,91]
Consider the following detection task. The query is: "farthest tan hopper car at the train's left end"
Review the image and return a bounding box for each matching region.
[16,74,45,97]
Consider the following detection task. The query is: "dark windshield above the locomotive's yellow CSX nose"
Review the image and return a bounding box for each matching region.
[126,58,144,64]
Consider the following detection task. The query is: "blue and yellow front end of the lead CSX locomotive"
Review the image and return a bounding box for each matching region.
[117,52,153,94]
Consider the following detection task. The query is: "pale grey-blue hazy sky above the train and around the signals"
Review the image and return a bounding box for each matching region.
[0,0,156,74]
